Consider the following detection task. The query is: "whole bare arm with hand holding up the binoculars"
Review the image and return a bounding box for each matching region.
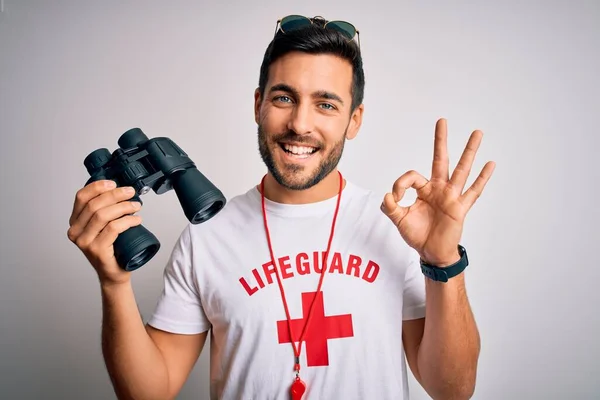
[67,181,206,400]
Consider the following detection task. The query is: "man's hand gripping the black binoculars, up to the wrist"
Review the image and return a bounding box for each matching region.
[67,180,142,285]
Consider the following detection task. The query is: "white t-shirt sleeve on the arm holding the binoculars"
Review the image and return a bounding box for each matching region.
[148,225,210,334]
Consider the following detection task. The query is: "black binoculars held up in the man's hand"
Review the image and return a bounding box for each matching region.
[83,128,226,271]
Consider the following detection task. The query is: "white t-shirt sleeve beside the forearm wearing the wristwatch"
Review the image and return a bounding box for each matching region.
[402,248,425,321]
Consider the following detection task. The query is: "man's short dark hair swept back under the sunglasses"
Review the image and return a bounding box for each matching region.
[258,17,365,111]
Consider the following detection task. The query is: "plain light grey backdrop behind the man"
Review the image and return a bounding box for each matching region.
[0,0,600,400]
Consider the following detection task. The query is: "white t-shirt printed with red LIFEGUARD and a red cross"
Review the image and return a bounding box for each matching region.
[149,182,425,400]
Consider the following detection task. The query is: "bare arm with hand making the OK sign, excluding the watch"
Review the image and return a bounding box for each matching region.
[382,119,495,399]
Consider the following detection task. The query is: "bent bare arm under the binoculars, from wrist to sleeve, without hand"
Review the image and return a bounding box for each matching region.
[102,283,206,400]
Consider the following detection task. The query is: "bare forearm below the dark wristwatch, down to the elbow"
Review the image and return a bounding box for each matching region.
[418,274,480,399]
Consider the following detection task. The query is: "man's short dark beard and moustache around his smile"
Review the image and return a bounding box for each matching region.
[258,125,347,190]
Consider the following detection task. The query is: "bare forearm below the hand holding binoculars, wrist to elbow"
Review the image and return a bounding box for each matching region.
[102,284,169,399]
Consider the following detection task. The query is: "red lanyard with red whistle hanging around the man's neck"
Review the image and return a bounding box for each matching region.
[260,171,344,399]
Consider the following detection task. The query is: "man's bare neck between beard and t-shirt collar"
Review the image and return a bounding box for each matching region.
[258,169,346,204]
